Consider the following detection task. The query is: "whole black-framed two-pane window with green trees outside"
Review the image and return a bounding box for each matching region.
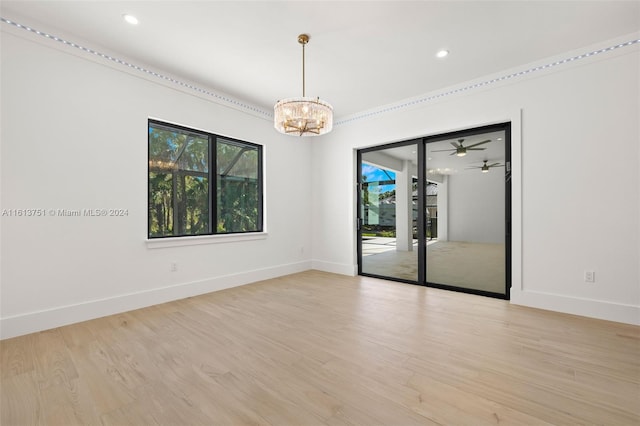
[148,120,262,238]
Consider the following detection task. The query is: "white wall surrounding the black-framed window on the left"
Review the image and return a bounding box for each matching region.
[0,25,311,338]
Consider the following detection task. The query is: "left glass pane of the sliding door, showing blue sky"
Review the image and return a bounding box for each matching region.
[358,142,420,282]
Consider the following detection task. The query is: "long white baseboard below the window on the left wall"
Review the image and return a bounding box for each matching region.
[0,261,311,339]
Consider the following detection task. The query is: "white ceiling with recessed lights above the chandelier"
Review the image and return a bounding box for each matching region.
[0,0,640,119]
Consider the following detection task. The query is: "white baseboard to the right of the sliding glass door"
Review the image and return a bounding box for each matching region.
[511,288,640,325]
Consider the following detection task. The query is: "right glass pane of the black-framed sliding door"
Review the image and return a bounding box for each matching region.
[425,130,506,295]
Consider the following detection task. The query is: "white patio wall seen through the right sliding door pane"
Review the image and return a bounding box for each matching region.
[450,168,505,243]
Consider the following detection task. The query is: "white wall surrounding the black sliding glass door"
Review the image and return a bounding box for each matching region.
[312,34,640,324]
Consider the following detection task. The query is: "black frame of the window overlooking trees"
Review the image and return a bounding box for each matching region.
[147,119,264,240]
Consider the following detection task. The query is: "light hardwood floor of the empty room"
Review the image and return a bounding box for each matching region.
[0,271,640,426]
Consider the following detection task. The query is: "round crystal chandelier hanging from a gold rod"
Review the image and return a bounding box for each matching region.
[273,34,333,136]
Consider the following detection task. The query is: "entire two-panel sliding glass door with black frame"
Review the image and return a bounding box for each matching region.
[358,123,511,298]
